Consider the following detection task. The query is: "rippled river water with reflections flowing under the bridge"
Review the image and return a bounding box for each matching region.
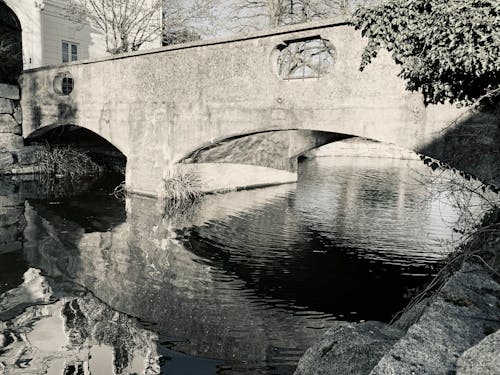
[0,157,478,375]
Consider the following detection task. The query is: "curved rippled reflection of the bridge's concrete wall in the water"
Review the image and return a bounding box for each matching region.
[24,183,328,369]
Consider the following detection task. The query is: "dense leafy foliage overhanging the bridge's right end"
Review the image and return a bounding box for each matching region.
[353,0,500,105]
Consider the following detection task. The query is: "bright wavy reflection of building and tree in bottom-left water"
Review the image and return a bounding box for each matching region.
[0,269,159,375]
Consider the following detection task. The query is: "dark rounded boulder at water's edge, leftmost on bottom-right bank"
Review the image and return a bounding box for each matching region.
[294,321,404,375]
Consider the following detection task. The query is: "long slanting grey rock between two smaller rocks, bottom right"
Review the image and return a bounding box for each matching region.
[370,263,500,375]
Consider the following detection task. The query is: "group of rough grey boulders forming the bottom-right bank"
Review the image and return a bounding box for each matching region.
[295,244,500,375]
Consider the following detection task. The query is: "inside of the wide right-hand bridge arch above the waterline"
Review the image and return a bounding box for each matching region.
[172,128,434,192]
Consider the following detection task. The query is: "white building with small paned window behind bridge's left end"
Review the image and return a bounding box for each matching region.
[0,0,161,69]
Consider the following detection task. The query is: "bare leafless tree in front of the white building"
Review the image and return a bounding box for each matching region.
[67,0,162,53]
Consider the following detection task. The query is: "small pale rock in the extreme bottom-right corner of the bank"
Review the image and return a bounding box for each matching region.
[457,330,500,375]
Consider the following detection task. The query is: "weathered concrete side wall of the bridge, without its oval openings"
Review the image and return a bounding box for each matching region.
[22,20,488,194]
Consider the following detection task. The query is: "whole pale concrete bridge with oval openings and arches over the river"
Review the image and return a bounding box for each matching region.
[21,20,496,195]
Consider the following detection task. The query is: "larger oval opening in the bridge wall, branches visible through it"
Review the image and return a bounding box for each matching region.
[278,36,335,79]
